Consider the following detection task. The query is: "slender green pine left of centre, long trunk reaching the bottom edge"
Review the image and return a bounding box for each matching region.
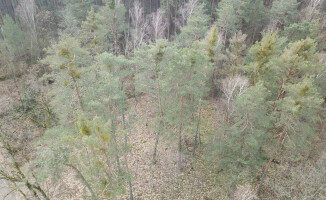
[89,53,134,200]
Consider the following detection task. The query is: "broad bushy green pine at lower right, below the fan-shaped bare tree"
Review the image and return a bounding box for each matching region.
[205,82,273,193]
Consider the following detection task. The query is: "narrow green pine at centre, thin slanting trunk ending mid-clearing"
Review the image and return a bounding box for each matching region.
[135,40,172,164]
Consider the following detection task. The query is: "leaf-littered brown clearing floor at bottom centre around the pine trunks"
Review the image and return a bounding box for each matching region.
[119,96,222,200]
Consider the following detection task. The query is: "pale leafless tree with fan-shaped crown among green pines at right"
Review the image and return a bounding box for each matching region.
[222,75,249,121]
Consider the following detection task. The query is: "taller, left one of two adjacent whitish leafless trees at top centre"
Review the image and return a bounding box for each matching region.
[130,1,148,50]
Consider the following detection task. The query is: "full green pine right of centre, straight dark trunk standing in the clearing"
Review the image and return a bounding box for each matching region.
[163,45,210,170]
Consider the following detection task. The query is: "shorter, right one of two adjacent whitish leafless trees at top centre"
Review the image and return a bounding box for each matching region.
[148,9,167,41]
